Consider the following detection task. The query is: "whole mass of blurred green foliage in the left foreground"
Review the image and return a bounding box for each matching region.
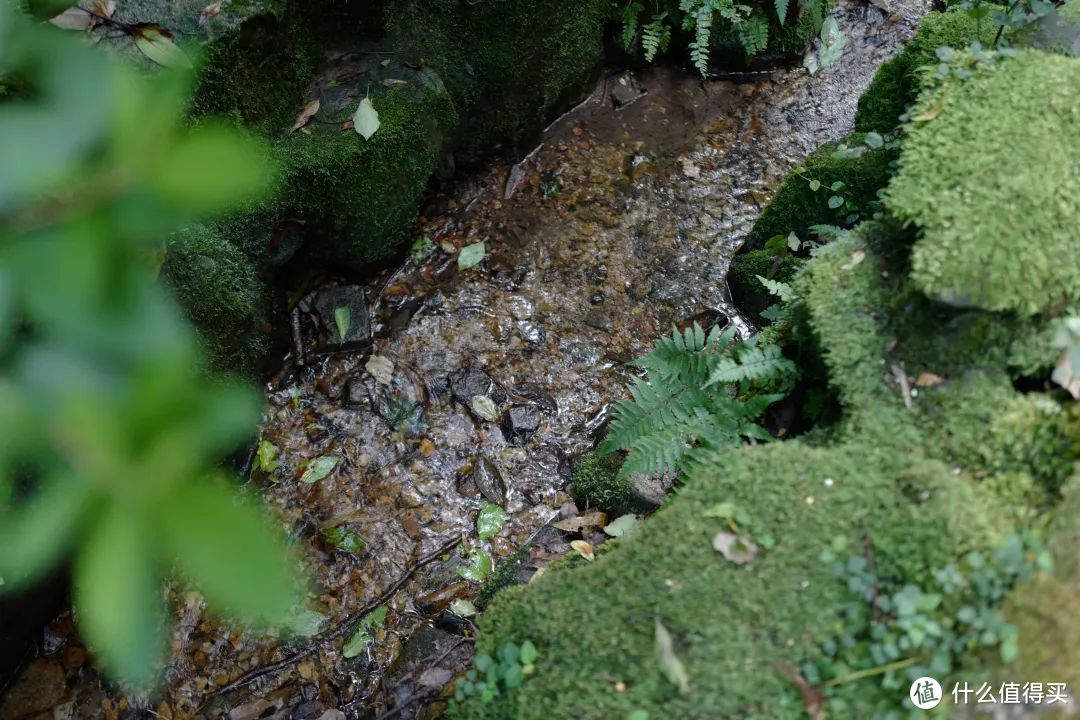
[0,5,297,683]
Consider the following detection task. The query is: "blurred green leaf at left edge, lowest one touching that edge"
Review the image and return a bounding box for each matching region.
[0,476,92,592]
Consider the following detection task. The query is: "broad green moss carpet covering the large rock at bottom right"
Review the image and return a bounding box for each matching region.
[467,441,1002,720]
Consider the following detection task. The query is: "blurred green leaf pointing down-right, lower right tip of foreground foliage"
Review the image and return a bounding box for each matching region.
[158,481,297,623]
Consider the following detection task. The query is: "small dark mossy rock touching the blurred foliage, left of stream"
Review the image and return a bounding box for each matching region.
[162,225,273,373]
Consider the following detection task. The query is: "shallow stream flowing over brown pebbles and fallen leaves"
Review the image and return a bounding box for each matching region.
[2,0,927,720]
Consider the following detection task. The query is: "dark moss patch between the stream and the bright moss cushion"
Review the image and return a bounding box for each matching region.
[746,135,896,248]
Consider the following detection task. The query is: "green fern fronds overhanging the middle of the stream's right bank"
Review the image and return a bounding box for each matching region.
[600,324,795,477]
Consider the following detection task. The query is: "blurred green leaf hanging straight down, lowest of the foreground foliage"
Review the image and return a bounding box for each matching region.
[75,505,163,685]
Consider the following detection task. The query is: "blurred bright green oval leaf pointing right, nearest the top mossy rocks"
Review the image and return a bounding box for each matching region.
[150,123,274,213]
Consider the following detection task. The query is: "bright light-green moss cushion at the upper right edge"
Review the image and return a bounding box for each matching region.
[887,51,1080,315]
